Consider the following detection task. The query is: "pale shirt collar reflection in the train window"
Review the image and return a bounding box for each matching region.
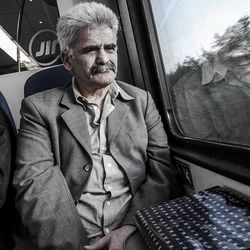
[201,55,228,85]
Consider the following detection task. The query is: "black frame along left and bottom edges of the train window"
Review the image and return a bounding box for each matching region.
[127,0,250,185]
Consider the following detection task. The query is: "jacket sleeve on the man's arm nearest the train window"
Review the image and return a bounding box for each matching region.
[123,93,182,224]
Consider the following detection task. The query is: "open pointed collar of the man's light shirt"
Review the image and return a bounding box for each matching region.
[72,77,134,104]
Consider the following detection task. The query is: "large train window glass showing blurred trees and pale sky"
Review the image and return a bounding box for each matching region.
[151,0,250,145]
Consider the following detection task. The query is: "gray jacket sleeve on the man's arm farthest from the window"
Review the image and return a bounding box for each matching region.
[14,99,86,250]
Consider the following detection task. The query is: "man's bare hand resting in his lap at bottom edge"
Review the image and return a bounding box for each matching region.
[85,225,136,250]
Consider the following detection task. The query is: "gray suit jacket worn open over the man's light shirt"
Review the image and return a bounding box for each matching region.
[14,82,182,250]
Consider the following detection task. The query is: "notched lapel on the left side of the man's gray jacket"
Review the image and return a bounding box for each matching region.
[61,85,92,157]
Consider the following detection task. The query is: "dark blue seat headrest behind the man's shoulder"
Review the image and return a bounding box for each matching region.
[24,65,72,97]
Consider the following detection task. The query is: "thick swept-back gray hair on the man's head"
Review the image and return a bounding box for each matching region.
[57,2,119,56]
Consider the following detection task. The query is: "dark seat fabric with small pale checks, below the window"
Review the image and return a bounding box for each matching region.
[135,187,250,250]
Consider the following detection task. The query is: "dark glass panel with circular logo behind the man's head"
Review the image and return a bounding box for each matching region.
[0,0,60,74]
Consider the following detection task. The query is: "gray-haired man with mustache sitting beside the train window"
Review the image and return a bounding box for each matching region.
[14,2,180,250]
